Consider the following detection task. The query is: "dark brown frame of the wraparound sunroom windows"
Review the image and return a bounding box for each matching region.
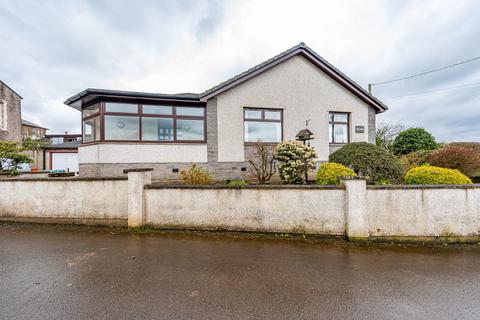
[82,100,207,145]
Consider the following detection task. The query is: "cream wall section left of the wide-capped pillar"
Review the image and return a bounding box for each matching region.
[0,178,127,225]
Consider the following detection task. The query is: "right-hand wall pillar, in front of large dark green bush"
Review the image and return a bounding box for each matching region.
[342,177,369,240]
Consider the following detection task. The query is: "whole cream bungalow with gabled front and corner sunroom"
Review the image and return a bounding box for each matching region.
[65,43,387,179]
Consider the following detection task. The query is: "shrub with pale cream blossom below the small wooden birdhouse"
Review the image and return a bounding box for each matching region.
[274,141,317,184]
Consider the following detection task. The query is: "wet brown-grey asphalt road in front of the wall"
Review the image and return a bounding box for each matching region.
[0,223,480,319]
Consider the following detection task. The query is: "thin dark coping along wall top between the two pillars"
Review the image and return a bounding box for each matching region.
[145,183,345,190]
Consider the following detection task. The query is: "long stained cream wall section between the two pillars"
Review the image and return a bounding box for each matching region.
[145,186,345,235]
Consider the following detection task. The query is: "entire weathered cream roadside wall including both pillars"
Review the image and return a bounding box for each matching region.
[0,168,480,241]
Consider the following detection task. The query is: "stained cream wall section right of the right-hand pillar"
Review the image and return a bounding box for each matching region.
[366,185,480,238]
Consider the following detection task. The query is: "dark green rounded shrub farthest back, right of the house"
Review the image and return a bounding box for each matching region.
[392,128,438,155]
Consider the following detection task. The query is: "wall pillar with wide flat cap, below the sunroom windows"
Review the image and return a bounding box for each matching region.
[123,168,153,228]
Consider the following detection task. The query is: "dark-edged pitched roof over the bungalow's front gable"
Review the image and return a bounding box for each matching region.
[200,42,388,112]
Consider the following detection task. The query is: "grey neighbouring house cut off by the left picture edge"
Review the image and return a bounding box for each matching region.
[0,80,22,142]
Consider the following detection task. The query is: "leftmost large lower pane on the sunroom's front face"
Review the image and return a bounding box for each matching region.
[105,116,140,140]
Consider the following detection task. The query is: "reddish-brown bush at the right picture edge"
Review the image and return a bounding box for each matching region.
[428,145,480,177]
